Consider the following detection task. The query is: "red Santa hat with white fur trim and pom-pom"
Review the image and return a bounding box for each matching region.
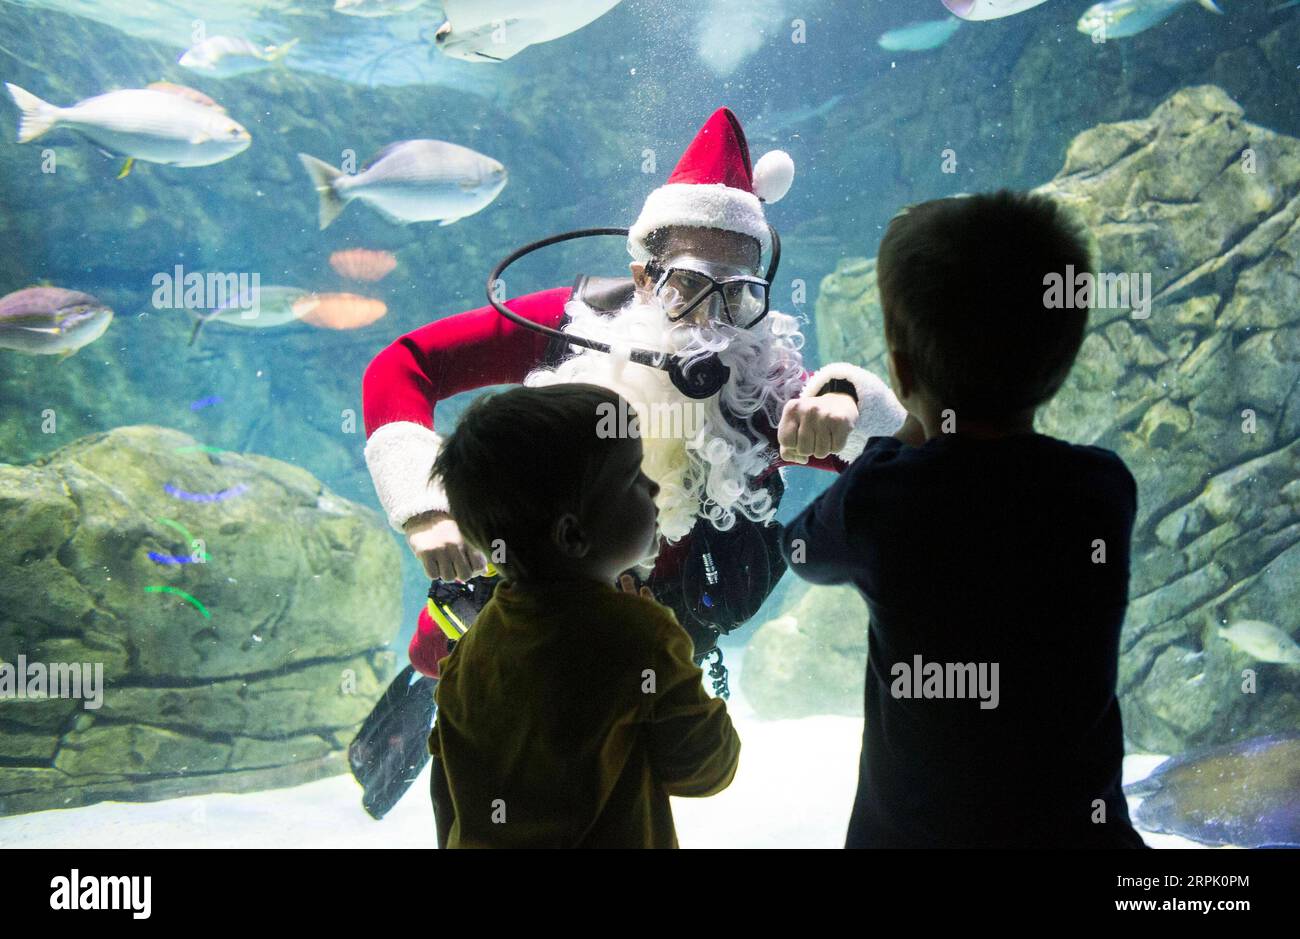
[628,108,794,261]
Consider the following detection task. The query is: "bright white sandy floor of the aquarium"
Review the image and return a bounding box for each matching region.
[0,650,1204,848]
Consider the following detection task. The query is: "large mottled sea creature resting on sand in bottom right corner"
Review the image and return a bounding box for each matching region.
[1125,734,1300,848]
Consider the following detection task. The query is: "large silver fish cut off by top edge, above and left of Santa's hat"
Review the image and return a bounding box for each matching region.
[434,0,620,62]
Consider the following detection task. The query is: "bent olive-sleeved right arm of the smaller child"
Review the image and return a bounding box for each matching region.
[647,614,740,796]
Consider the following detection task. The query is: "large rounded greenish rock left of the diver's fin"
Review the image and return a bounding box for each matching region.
[0,427,402,814]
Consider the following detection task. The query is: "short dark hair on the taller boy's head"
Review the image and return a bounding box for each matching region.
[876,190,1092,420]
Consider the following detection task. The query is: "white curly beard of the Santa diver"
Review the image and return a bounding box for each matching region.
[524,293,803,556]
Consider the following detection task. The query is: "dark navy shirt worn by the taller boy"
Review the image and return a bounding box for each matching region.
[781,433,1143,847]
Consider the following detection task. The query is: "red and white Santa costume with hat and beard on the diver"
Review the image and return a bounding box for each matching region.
[363,108,906,678]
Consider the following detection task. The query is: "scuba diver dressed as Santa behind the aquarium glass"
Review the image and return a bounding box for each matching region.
[348,108,906,818]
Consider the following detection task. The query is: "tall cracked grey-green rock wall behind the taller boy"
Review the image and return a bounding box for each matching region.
[745,86,1300,738]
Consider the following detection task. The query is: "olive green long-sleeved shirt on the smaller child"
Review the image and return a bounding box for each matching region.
[429,580,740,848]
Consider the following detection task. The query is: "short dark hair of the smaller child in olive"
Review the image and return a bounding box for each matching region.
[429,382,620,577]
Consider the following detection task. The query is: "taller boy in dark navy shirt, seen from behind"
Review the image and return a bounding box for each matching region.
[783,191,1144,848]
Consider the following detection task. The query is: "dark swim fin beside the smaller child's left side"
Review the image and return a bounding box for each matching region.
[347,665,438,819]
